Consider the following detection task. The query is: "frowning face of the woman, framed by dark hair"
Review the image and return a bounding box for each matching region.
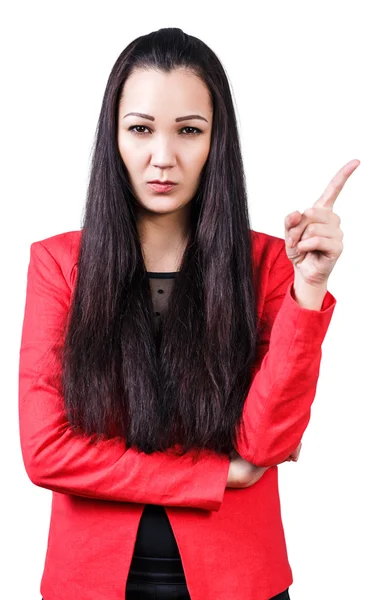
[118,69,213,214]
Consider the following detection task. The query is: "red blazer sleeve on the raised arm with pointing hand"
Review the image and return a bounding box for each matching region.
[237,240,336,467]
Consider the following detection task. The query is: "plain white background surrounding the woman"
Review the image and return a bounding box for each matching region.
[0,0,381,600]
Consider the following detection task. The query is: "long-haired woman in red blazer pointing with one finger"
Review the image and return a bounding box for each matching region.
[19,28,359,600]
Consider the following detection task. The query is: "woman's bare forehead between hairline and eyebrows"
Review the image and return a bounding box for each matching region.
[120,69,212,117]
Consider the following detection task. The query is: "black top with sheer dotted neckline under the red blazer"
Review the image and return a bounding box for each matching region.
[134,271,180,558]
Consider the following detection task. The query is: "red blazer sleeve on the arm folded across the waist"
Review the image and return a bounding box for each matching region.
[19,242,230,510]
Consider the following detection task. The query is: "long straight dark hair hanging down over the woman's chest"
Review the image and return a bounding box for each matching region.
[56,28,258,455]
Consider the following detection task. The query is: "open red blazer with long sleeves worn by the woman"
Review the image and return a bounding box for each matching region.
[19,231,336,600]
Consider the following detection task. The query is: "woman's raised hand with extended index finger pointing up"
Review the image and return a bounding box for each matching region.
[284,159,360,285]
